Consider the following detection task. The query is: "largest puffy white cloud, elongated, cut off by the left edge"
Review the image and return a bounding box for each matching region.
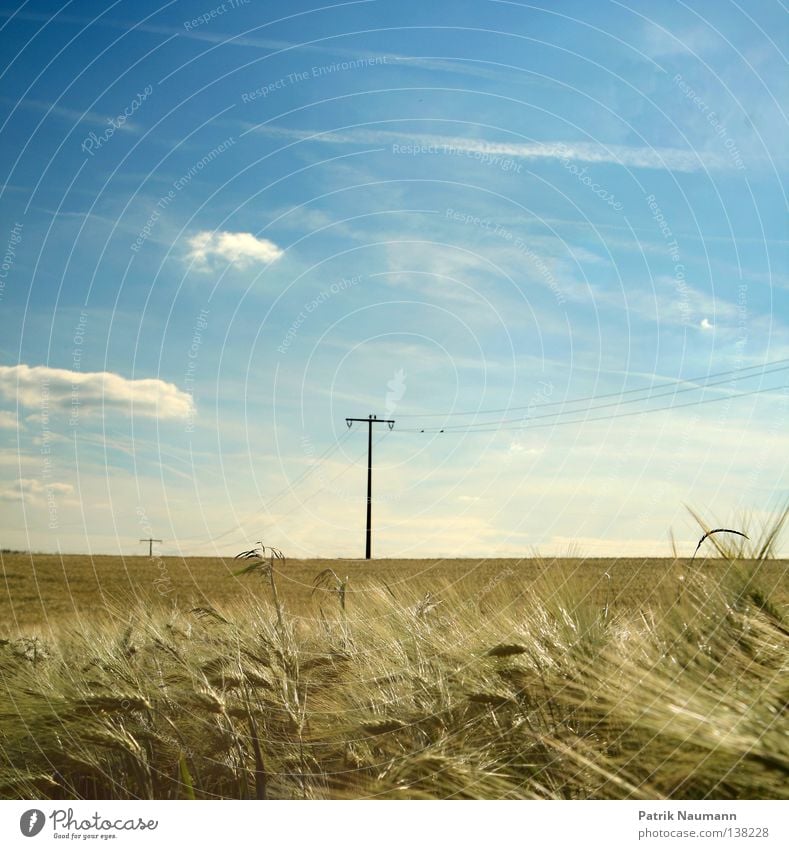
[0,363,194,419]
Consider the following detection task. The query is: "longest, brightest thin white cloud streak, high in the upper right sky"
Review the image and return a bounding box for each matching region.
[248,125,733,172]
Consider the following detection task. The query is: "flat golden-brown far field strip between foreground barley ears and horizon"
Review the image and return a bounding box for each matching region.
[0,554,789,638]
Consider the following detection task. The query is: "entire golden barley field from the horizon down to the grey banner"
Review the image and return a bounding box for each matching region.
[0,517,789,799]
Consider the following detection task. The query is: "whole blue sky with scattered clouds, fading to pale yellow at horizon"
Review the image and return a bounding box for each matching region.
[0,0,789,557]
